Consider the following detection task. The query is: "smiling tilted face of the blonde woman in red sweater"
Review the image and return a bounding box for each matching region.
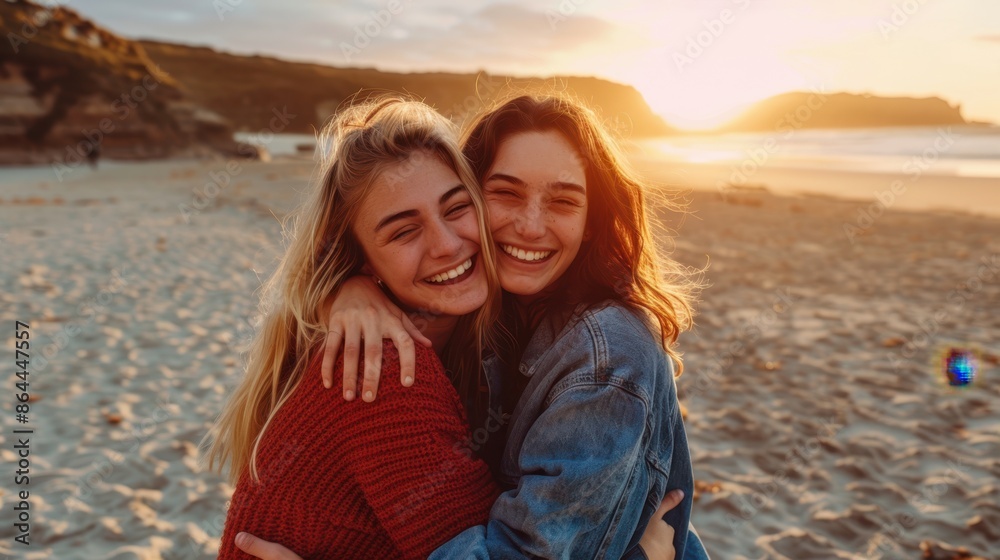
[353,152,488,316]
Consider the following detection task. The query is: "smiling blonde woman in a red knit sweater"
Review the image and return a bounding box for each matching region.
[209,98,498,558]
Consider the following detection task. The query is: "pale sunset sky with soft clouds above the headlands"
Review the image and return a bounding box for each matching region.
[70,0,1000,128]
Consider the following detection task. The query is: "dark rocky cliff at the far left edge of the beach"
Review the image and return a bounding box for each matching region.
[0,0,256,165]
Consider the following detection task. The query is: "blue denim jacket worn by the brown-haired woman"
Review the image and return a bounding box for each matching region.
[430,302,707,559]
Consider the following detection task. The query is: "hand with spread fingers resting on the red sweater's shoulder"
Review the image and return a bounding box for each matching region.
[321,276,431,402]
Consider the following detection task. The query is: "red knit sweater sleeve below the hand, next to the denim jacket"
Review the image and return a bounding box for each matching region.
[342,342,499,558]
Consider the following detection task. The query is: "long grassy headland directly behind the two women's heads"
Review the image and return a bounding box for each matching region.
[140,41,672,136]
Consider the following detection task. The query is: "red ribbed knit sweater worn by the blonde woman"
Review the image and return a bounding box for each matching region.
[219,342,499,560]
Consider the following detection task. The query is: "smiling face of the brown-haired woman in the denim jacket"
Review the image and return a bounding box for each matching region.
[483,131,587,299]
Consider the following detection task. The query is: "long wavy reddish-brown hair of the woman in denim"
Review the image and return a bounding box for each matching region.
[462,95,701,376]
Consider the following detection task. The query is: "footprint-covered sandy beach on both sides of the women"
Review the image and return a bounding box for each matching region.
[0,154,1000,560]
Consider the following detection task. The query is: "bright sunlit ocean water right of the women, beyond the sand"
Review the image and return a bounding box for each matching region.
[634,126,1000,178]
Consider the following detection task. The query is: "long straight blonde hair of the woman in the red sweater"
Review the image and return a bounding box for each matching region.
[204,96,500,483]
